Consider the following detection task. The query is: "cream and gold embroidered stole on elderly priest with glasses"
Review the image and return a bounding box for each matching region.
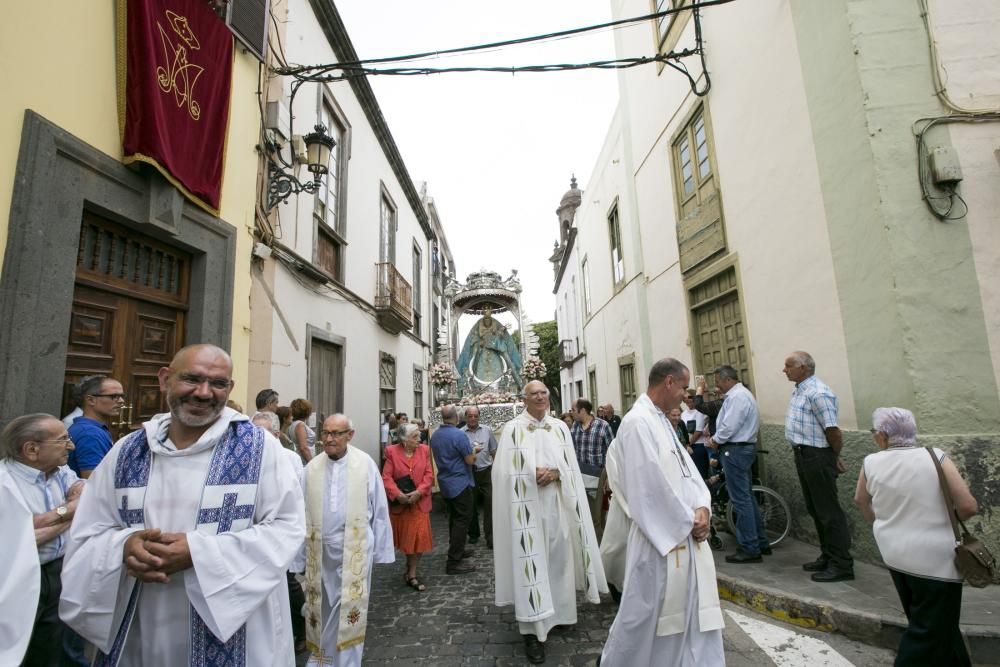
[304,445,371,659]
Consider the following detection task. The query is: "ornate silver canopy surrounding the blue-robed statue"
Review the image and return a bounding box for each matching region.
[436,270,538,403]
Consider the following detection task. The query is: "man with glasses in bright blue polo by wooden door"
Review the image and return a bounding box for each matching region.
[69,375,125,479]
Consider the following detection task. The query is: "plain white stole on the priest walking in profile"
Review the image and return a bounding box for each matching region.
[644,413,724,636]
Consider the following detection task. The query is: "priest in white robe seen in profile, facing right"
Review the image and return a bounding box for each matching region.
[600,359,726,667]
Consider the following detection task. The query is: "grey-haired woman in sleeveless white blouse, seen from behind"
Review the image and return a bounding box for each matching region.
[854,408,978,666]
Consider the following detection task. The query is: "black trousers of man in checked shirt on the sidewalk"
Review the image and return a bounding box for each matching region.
[792,445,854,570]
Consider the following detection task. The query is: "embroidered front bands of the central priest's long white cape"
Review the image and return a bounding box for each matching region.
[509,417,600,623]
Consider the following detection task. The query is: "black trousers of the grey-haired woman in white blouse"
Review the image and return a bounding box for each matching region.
[889,569,972,667]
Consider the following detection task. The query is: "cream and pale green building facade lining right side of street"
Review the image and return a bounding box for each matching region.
[575,0,1000,556]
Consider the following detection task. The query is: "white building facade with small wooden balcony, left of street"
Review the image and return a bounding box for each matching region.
[249,0,452,460]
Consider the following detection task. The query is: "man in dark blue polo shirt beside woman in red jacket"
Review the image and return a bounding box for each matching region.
[431,405,478,574]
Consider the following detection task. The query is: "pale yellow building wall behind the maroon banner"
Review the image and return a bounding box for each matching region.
[0,0,260,400]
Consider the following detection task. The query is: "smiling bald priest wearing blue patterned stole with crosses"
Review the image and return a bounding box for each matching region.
[59,345,305,667]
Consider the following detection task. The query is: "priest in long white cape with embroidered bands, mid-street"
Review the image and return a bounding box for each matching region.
[492,380,608,663]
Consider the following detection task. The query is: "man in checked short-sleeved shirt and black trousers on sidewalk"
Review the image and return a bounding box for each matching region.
[783,351,854,582]
